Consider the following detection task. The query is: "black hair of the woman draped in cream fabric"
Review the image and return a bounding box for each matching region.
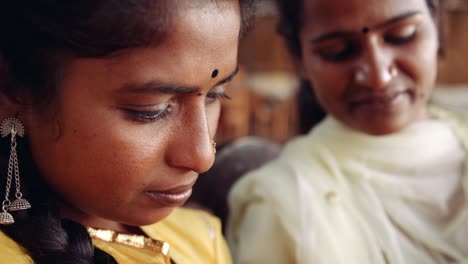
[276,0,445,133]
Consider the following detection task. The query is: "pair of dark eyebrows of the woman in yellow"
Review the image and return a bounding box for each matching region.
[118,65,239,94]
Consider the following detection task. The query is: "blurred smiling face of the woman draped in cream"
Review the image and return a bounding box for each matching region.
[300,0,438,135]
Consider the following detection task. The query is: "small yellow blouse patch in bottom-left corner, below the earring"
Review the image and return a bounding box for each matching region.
[0,231,33,264]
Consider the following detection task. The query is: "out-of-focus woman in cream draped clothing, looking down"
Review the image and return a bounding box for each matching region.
[228,0,468,264]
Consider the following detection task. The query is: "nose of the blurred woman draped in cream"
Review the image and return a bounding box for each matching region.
[354,38,398,89]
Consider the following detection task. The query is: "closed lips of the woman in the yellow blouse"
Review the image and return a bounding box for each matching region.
[145,184,193,207]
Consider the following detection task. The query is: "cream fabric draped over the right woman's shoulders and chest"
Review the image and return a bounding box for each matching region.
[228,108,468,264]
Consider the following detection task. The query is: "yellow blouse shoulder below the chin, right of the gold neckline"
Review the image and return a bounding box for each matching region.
[142,208,230,264]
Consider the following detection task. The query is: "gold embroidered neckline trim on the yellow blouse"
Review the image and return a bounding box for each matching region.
[87,227,169,257]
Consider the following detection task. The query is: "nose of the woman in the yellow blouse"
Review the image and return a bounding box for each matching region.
[166,106,215,173]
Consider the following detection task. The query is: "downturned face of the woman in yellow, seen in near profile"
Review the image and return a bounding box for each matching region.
[0,0,245,233]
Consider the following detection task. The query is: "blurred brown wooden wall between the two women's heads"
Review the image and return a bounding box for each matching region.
[217,12,298,144]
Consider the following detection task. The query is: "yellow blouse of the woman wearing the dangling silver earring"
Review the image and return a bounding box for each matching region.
[0,208,231,264]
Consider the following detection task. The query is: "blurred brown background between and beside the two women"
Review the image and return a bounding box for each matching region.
[186,0,468,229]
